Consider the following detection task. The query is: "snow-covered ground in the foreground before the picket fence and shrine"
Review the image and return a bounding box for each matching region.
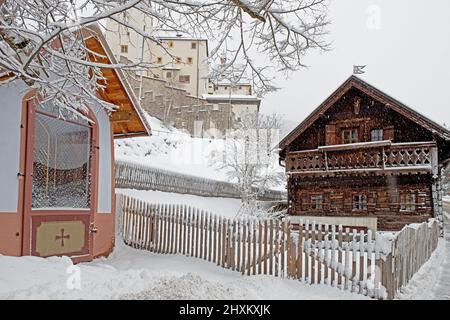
[0,242,369,300]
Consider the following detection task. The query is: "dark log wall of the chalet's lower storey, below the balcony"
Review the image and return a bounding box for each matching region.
[288,175,433,230]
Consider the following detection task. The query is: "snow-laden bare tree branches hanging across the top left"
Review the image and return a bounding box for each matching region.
[0,0,328,115]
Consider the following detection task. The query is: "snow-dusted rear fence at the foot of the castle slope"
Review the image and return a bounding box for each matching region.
[116,160,287,201]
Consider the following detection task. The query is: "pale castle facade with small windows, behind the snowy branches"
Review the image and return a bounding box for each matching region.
[105,9,208,96]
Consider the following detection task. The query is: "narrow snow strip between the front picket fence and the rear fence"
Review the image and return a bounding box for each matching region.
[116,189,241,218]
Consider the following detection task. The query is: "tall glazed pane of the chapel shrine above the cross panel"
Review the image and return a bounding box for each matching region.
[32,113,91,209]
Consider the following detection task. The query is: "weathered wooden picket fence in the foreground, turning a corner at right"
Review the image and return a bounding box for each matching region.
[119,195,439,299]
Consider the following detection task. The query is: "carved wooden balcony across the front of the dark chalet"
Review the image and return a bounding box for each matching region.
[286,141,438,176]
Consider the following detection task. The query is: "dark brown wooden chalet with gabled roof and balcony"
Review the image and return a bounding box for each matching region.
[280,76,450,230]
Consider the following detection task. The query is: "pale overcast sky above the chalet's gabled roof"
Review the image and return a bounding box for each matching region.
[261,0,450,130]
